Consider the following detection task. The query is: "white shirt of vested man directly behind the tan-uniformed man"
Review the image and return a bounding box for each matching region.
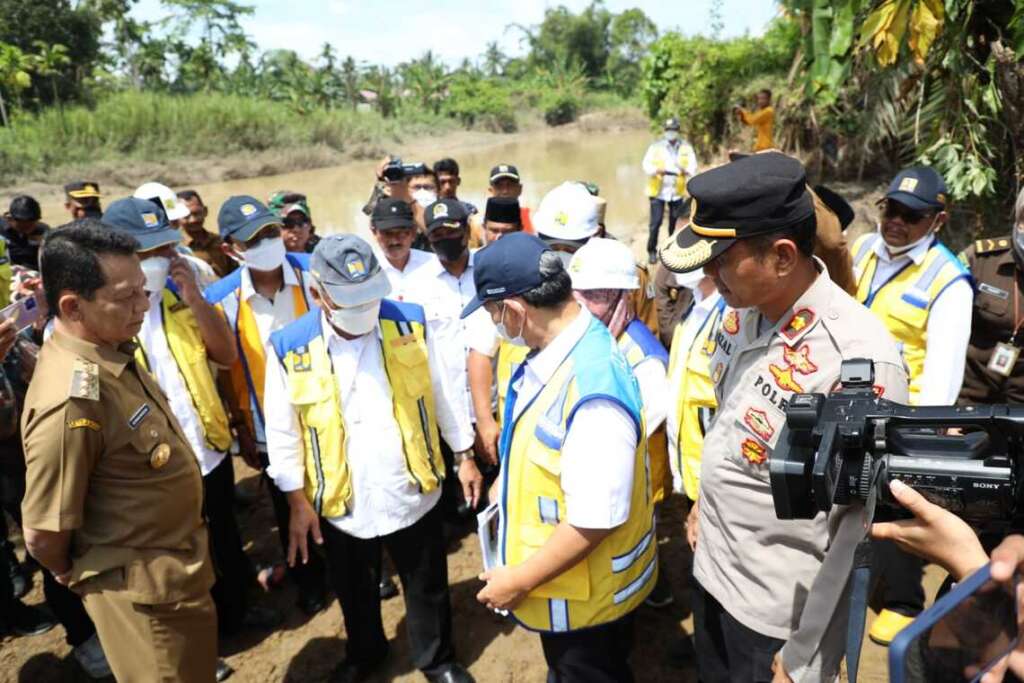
[138,292,224,476]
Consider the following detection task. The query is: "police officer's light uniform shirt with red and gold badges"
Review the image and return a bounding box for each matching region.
[693,261,907,682]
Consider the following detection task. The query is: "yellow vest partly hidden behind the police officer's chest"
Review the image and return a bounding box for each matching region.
[669,300,725,501]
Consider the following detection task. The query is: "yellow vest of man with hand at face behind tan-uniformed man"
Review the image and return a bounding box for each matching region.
[135,289,231,453]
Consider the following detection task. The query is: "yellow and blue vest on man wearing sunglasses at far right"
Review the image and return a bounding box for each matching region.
[853,232,971,404]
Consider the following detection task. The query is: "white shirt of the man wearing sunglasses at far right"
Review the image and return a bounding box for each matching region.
[870,240,974,405]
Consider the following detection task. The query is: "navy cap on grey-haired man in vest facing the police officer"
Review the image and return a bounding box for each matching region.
[461,232,551,317]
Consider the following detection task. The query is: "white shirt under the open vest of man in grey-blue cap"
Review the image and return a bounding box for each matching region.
[265,313,472,539]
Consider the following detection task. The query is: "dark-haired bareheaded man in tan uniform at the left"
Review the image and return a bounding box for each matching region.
[22,222,217,683]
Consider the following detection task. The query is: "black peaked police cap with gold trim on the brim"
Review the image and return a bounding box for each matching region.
[660,152,814,272]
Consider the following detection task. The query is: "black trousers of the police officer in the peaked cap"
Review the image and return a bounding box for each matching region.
[693,580,785,683]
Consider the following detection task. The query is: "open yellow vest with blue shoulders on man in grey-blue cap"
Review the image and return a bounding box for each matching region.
[270,299,444,517]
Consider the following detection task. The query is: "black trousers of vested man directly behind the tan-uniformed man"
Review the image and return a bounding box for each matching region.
[203,455,255,634]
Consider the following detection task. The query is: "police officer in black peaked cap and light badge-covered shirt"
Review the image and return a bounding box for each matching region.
[662,153,907,683]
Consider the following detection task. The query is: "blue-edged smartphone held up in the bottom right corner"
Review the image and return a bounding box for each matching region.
[890,567,1020,683]
